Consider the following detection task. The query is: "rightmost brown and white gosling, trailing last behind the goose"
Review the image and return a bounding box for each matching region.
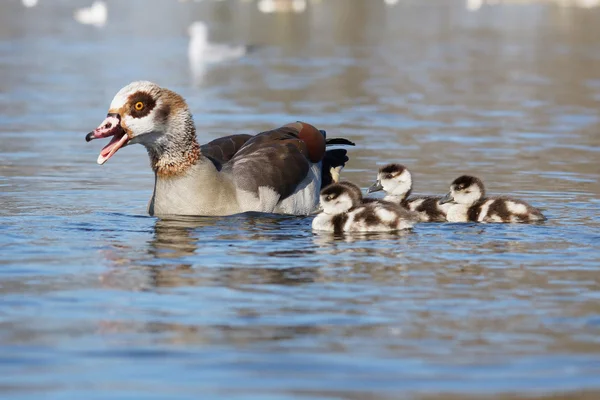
[441,175,546,223]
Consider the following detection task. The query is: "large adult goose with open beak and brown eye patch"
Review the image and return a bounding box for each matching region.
[86,81,354,216]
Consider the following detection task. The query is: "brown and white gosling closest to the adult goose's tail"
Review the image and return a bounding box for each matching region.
[312,182,418,233]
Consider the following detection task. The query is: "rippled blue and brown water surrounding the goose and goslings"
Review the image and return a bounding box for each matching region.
[0,0,600,399]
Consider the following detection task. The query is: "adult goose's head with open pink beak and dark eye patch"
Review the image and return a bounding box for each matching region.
[85,81,195,164]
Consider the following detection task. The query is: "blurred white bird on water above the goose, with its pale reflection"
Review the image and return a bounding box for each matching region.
[188,21,255,83]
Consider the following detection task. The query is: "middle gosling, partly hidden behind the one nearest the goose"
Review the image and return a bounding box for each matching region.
[367,164,450,222]
